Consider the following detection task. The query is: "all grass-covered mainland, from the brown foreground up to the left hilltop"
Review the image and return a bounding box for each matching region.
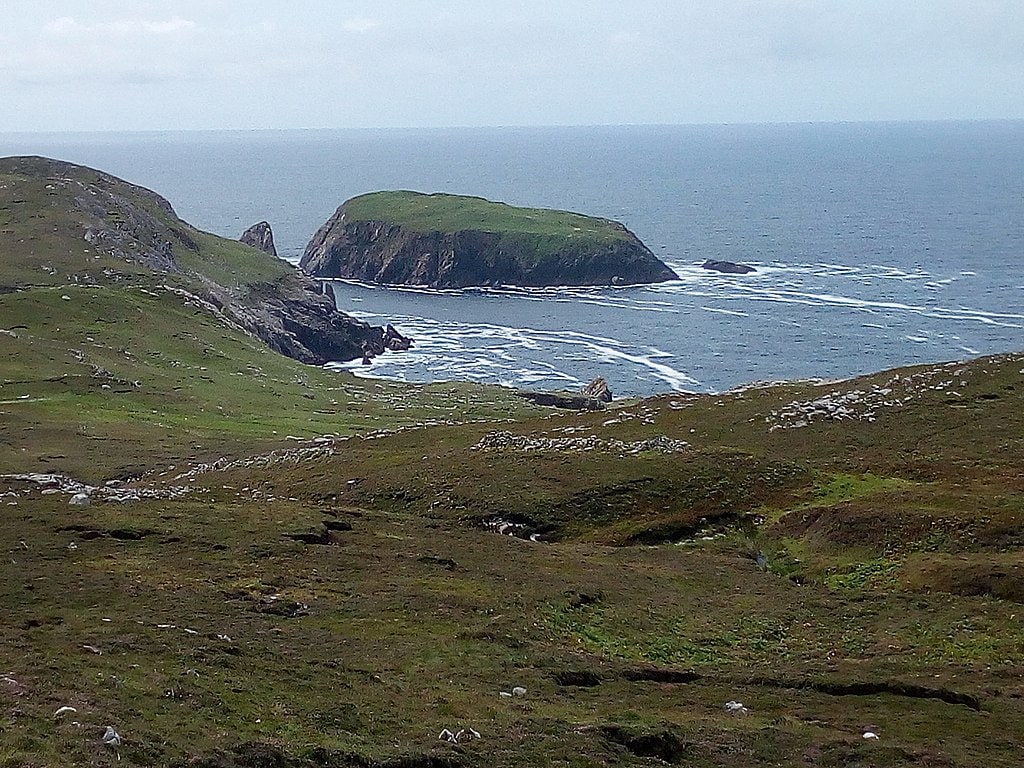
[0,157,1024,768]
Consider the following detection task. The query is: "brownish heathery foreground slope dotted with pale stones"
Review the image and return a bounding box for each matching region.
[0,357,1024,766]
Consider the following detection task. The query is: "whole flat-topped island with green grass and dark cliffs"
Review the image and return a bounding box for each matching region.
[299,191,678,288]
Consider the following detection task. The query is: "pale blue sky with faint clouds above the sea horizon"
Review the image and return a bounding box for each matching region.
[0,0,1024,132]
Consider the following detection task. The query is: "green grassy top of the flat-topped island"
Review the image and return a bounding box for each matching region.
[345,191,631,241]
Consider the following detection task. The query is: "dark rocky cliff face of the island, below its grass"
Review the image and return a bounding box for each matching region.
[299,206,678,288]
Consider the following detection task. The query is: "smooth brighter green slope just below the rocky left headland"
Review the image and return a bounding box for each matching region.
[0,284,540,482]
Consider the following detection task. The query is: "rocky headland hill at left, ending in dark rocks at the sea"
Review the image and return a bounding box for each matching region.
[0,158,381,365]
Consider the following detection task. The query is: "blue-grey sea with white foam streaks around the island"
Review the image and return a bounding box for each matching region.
[0,121,1024,395]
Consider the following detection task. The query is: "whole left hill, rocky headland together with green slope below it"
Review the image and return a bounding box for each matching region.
[0,158,540,482]
